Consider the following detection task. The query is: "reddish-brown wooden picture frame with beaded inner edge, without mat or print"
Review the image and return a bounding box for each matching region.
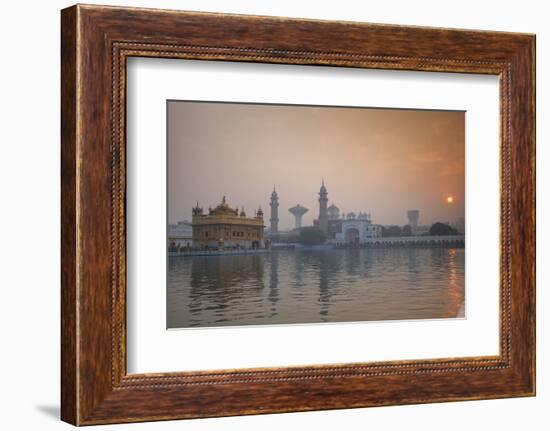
[61,5,535,425]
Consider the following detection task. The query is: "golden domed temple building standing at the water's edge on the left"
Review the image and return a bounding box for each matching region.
[191,196,265,249]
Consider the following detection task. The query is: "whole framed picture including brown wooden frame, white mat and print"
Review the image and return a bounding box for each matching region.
[61,5,535,425]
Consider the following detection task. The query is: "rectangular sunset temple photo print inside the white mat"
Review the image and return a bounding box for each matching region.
[166,100,466,329]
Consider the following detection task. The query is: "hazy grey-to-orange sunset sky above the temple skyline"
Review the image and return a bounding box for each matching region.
[168,101,465,229]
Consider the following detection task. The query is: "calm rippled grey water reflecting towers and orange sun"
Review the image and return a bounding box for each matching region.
[167,248,464,328]
